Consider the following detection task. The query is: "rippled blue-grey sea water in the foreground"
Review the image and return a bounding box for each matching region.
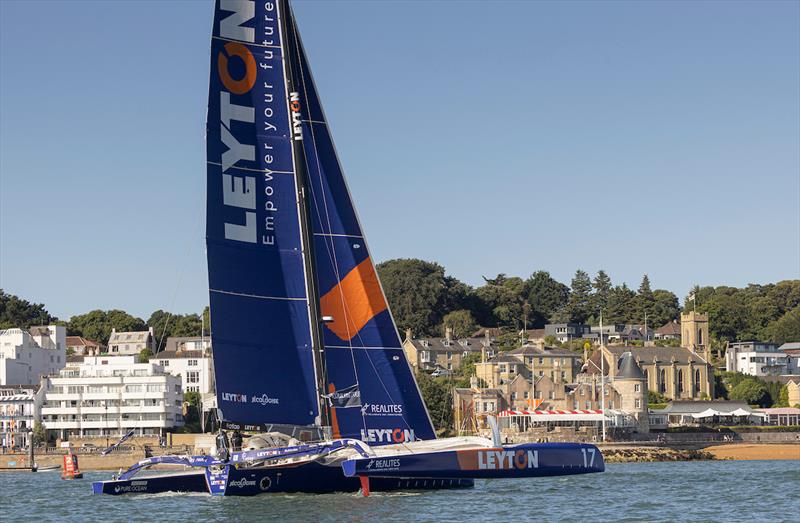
[0,461,800,523]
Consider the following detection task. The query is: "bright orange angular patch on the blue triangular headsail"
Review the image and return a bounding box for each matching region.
[319,258,386,341]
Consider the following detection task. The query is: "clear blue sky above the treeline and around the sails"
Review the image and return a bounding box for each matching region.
[0,0,800,319]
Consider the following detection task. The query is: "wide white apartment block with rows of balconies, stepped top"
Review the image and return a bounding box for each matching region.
[42,356,183,439]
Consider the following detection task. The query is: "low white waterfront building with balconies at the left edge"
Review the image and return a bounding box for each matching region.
[0,385,44,448]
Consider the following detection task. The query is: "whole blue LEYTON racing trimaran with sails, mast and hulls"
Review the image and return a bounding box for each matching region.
[93,0,604,496]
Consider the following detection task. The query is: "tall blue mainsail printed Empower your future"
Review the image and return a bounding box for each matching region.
[206,0,319,425]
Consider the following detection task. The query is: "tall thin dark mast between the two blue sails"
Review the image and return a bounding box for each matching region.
[278,0,330,434]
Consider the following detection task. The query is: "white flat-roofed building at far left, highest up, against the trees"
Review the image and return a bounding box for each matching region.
[0,325,67,386]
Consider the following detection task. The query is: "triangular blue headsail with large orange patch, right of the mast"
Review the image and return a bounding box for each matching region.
[278,3,435,444]
